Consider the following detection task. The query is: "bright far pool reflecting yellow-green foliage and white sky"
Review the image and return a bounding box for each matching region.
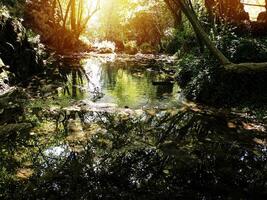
[57,54,179,108]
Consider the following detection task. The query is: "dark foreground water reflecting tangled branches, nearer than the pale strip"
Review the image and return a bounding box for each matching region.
[0,104,267,199]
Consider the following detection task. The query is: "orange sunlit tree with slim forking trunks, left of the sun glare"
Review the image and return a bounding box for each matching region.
[26,0,100,50]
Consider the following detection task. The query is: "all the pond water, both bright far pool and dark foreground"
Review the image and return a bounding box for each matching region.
[0,54,267,200]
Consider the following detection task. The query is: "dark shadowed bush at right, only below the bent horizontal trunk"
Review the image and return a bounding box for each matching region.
[177,49,267,106]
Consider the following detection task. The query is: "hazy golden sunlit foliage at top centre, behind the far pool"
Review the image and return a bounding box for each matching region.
[88,0,173,52]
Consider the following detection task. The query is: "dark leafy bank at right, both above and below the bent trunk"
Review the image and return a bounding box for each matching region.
[177,36,267,107]
